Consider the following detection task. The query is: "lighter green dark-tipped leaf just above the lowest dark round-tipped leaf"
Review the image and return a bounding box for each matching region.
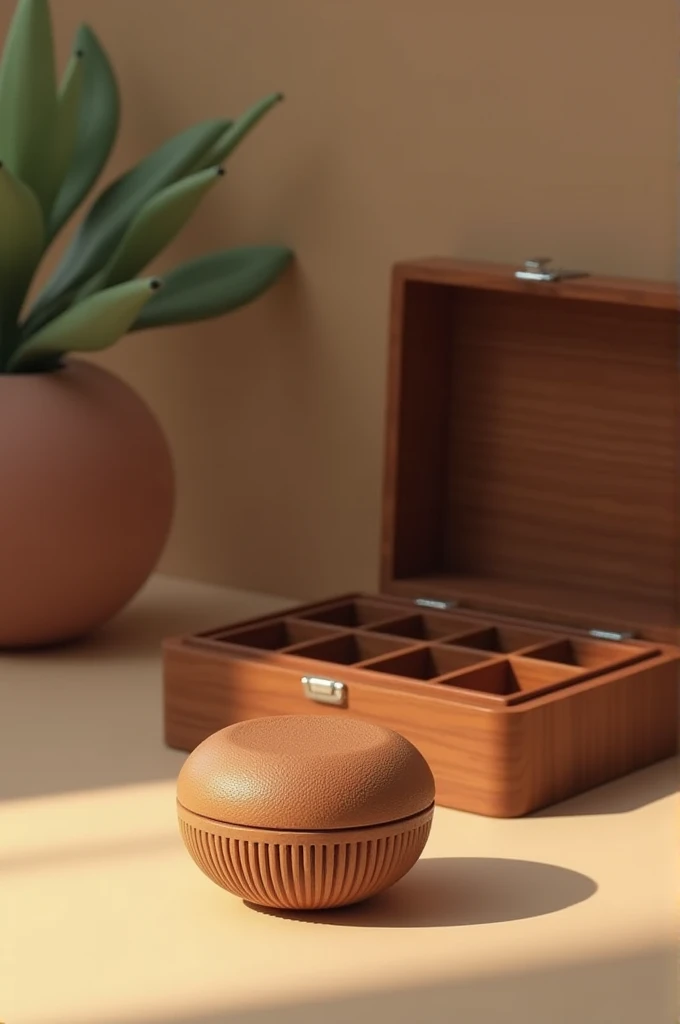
[95,167,223,288]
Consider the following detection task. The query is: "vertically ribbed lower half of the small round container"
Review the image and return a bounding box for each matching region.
[179,808,432,910]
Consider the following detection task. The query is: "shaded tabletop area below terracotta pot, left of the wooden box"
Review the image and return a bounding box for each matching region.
[0,578,290,800]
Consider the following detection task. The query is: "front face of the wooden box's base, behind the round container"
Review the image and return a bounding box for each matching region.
[164,641,510,816]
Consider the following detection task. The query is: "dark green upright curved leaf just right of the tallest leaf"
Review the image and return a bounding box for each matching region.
[48,25,121,239]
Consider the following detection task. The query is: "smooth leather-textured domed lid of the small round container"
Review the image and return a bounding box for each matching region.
[177,715,434,831]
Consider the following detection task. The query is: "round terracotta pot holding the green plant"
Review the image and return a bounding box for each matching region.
[0,361,174,647]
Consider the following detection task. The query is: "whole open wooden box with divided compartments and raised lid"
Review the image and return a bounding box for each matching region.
[164,259,680,817]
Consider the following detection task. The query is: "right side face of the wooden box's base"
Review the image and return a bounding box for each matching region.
[505,658,680,817]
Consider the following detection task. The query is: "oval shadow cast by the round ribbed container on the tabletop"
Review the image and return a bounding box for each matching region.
[242,857,597,928]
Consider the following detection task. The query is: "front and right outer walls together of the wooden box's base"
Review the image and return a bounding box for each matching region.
[164,640,680,817]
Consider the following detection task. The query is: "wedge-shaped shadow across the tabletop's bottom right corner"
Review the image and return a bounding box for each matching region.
[75,933,677,1024]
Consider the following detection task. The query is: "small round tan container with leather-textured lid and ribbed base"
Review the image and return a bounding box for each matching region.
[177,715,434,910]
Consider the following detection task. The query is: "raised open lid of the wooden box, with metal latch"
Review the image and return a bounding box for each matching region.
[381,259,680,643]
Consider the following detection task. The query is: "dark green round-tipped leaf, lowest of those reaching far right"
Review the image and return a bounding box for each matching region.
[132,246,293,331]
